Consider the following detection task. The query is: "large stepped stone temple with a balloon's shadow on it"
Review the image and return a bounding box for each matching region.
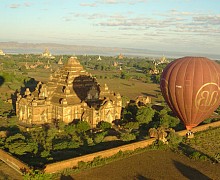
[16,57,122,127]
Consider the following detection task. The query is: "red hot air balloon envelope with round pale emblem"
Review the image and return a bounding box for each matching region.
[160,57,220,130]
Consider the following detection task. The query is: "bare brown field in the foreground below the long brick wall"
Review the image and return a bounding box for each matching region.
[70,151,220,180]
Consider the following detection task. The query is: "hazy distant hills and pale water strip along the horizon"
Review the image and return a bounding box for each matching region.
[0,42,220,60]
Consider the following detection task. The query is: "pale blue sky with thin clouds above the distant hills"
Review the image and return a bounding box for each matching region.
[0,0,220,54]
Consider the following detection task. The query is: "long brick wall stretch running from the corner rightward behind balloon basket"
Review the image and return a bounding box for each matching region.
[44,121,220,173]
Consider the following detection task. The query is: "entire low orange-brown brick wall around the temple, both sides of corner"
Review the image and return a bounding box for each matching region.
[0,121,220,174]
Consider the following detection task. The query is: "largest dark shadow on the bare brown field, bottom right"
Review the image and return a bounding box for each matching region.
[173,160,211,180]
